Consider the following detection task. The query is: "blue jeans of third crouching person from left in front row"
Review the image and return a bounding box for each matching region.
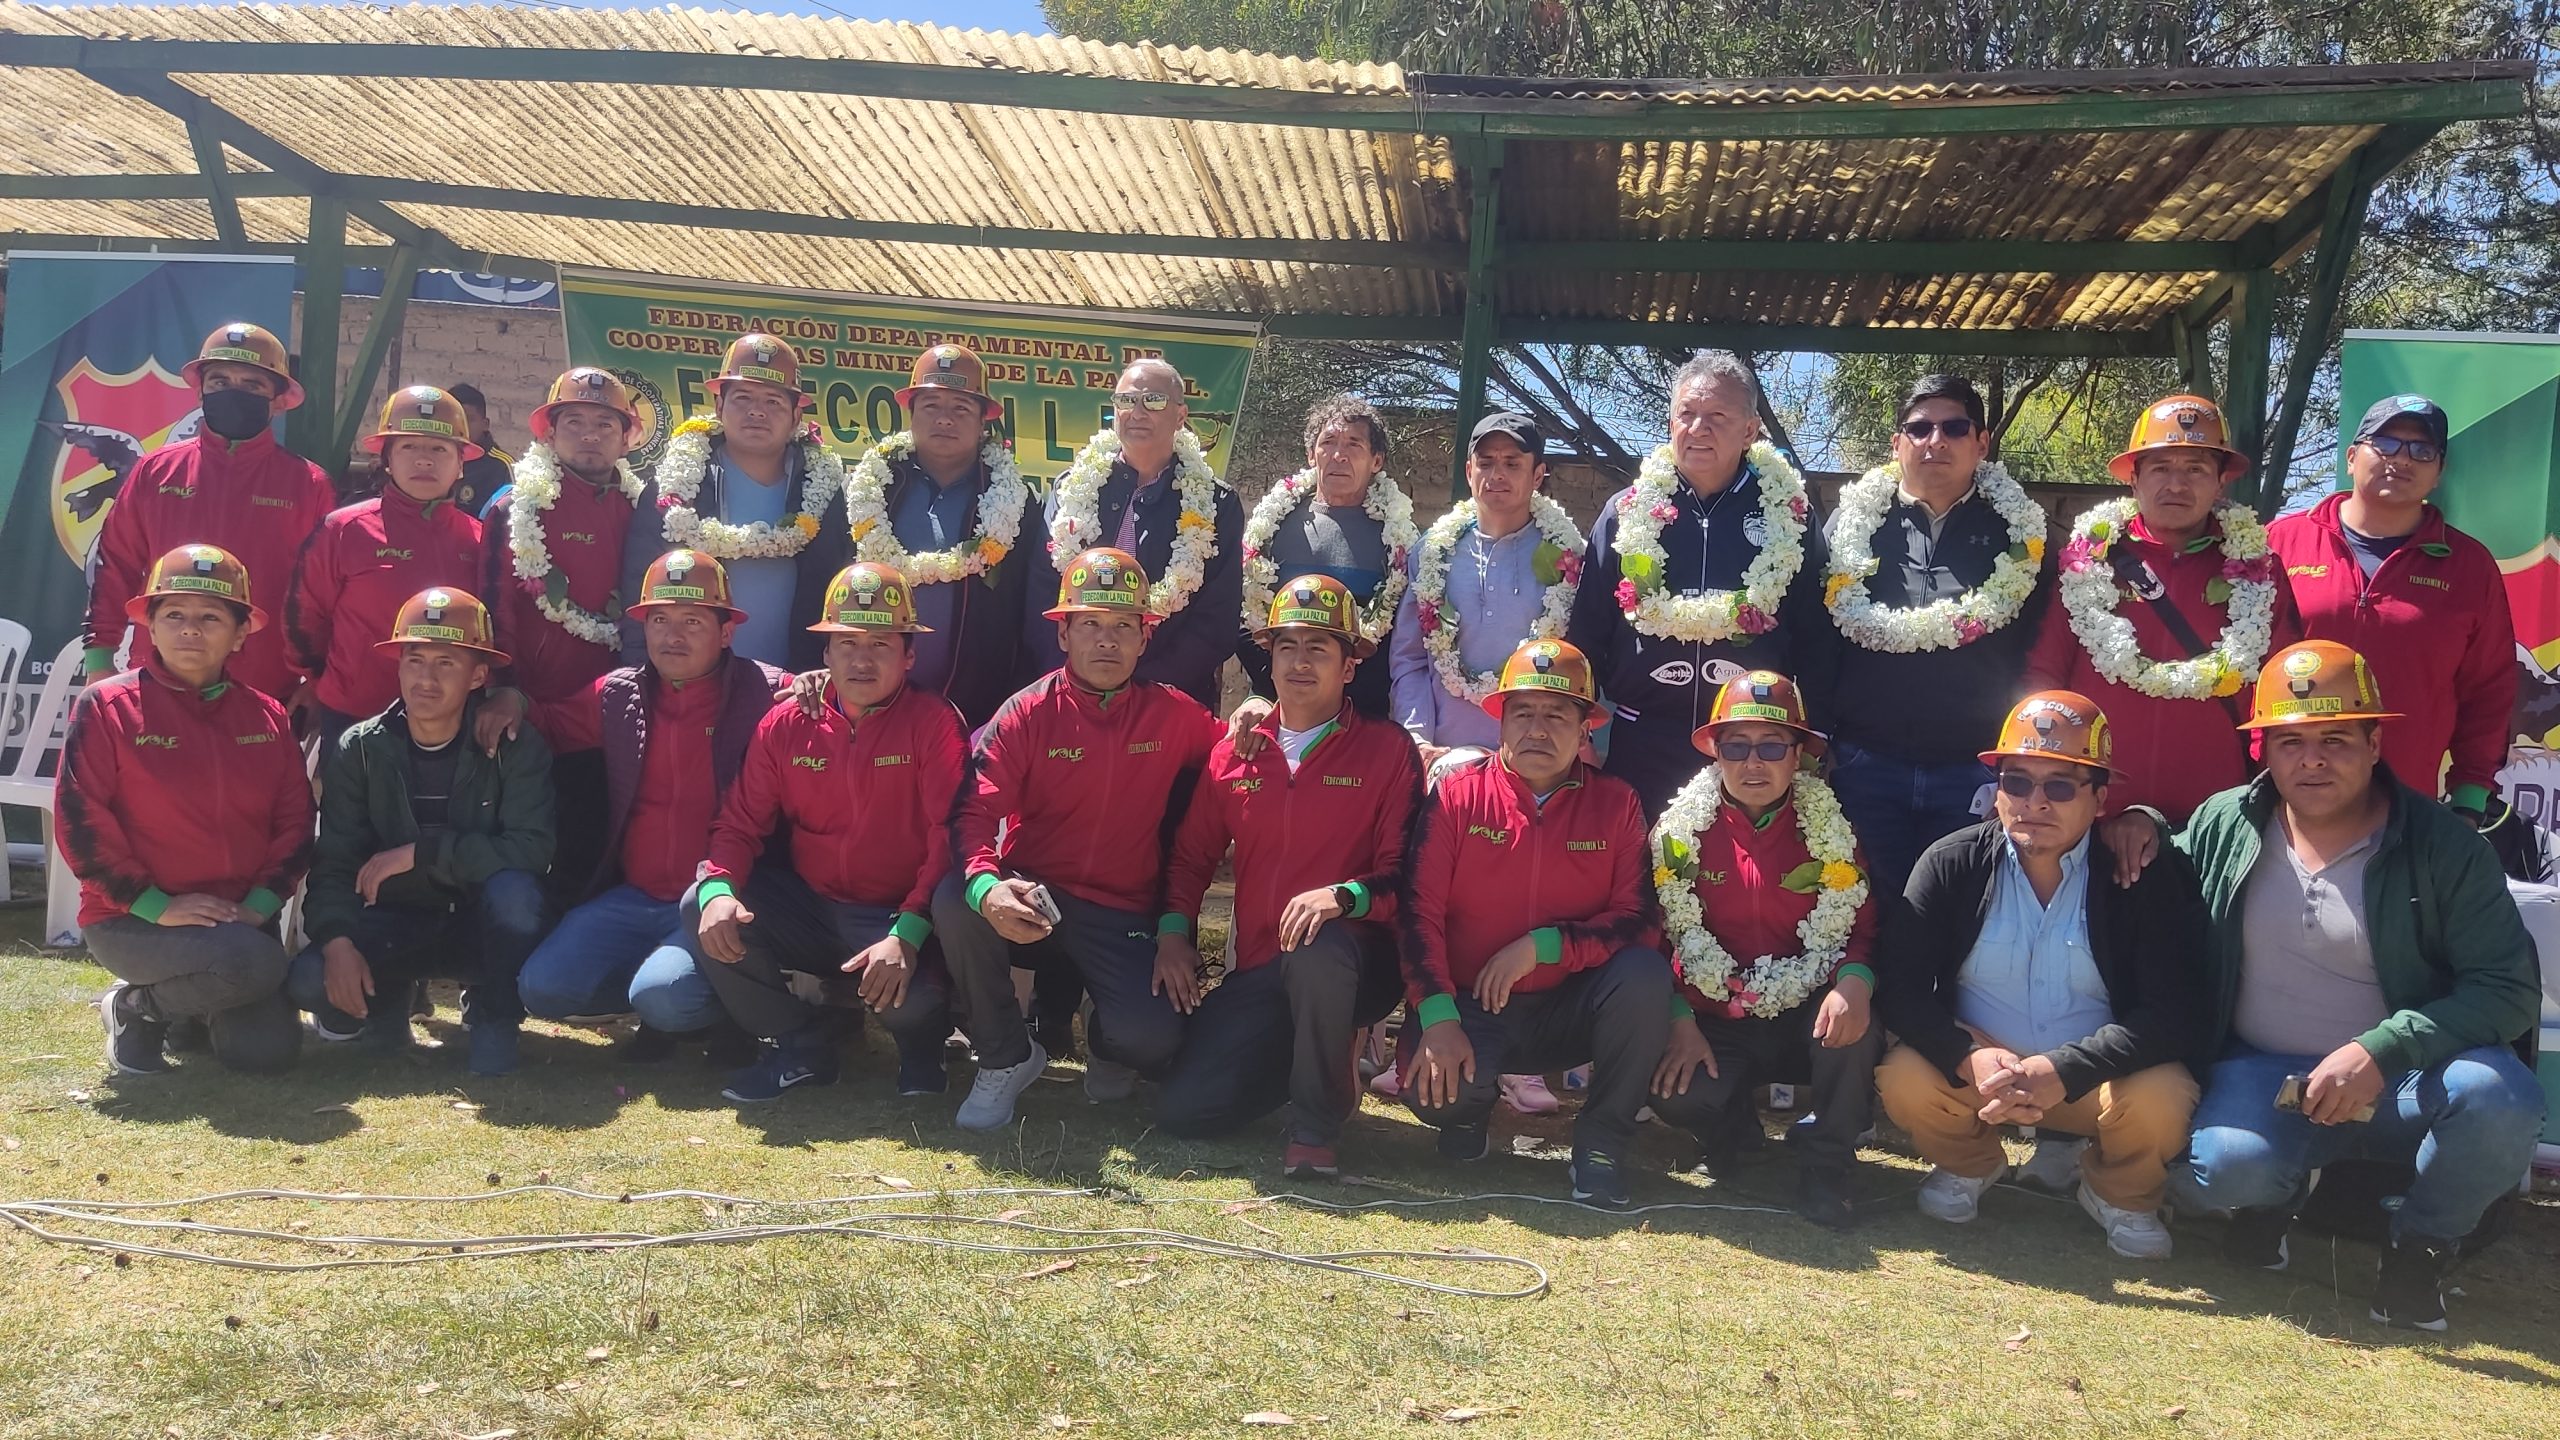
[520,884,719,1033]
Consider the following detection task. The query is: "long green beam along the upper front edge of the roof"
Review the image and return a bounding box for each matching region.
[0,36,2529,138]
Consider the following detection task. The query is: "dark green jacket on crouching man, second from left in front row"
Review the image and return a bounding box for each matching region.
[302,692,558,943]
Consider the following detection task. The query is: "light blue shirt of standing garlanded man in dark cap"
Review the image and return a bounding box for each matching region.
[1388,515,1546,751]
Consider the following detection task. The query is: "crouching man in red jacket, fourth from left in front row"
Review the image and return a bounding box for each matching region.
[686,561,968,1102]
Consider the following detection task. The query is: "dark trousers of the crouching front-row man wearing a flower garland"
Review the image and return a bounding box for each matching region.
[1654,992,1884,1171]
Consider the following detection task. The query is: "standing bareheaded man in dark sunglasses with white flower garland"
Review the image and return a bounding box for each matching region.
[1823,374,2053,894]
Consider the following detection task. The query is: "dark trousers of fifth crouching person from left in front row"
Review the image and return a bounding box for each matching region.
[934,871,1183,1079]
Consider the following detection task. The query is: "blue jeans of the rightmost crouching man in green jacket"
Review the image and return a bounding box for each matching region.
[2168,1045,2542,1243]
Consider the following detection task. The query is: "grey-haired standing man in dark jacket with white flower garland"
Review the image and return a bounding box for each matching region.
[1569,351,1838,815]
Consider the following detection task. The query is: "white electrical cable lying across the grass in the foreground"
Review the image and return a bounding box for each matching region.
[0,1184,1784,1299]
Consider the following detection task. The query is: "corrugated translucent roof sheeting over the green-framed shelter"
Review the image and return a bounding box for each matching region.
[0,0,2519,331]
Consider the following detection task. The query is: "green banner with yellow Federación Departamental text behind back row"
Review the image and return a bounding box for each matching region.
[561,269,1257,479]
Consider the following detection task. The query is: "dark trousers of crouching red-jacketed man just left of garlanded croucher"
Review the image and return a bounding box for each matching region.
[1403,945,1672,1158]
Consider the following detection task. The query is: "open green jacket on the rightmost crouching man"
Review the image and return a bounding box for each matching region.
[2176,769,2542,1076]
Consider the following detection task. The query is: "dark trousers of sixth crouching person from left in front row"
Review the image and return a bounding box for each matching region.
[1155,920,1405,1145]
